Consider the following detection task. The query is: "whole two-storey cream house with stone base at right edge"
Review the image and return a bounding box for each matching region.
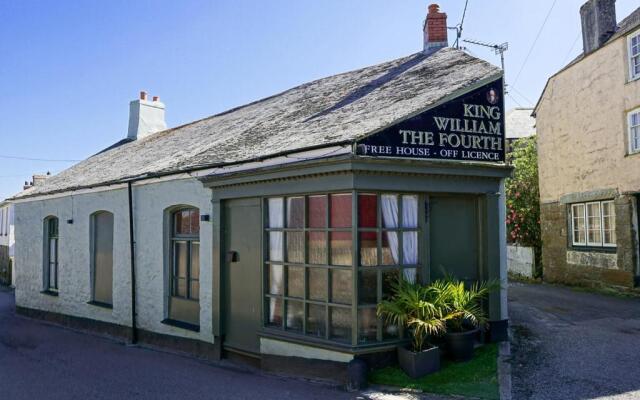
[535,0,640,287]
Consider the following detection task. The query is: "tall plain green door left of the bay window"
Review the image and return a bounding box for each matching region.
[223,199,262,354]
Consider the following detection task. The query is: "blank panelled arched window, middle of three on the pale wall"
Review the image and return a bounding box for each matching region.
[90,211,113,307]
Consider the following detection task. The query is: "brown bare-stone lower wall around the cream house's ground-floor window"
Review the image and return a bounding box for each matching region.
[541,196,638,287]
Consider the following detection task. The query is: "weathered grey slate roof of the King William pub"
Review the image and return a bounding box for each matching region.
[14,48,502,198]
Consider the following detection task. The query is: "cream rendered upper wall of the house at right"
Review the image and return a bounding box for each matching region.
[536,37,640,203]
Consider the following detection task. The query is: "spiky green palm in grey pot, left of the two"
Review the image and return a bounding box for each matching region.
[378,278,447,379]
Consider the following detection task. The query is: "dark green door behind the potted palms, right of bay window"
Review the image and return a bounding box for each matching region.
[429,196,479,282]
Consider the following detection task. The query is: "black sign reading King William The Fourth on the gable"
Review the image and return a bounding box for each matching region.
[356,79,505,162]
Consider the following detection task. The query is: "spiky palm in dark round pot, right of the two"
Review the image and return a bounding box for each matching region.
[430,277,500,361]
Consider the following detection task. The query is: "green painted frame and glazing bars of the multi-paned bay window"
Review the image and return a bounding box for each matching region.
[262,190,428,347]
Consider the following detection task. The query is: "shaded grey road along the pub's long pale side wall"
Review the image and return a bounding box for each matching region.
[0,287,452,400]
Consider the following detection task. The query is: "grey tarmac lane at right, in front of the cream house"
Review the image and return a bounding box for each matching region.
[509,283,640,400]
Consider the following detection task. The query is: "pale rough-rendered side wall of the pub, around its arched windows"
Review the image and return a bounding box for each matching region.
[15,179,214,342]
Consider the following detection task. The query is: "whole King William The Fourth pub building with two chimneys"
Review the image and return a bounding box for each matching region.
[12,5,511,382]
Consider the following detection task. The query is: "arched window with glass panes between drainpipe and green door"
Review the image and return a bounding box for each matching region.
[169,207,200,325]
